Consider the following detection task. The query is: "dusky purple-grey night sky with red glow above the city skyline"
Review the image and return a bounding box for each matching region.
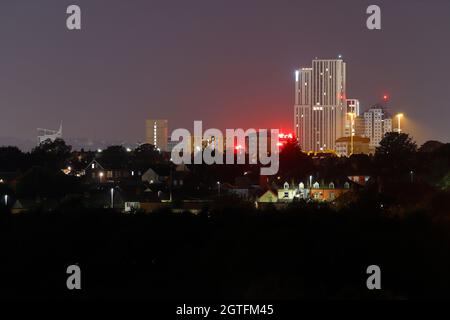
[0,0,450,142]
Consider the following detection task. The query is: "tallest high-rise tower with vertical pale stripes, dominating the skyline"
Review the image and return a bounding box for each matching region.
[294,59,346,151]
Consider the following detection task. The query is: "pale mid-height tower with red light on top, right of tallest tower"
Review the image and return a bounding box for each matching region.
[364,104,392,152]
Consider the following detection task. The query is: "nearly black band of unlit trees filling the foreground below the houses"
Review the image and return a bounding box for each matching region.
[0,199,450,300]
